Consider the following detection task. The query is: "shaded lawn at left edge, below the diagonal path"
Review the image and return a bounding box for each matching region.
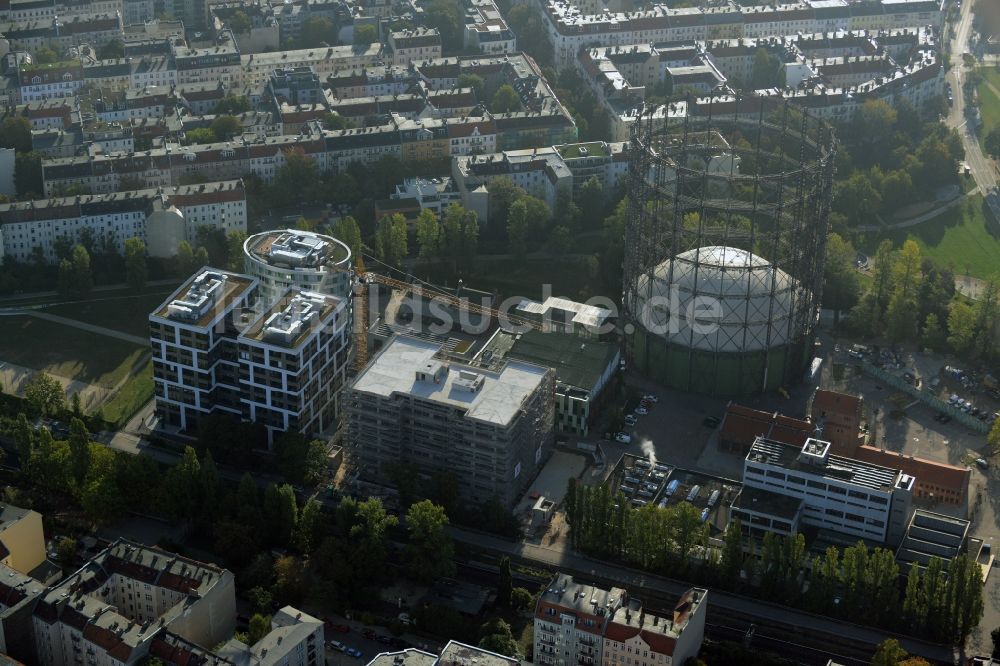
[0,316,149,388]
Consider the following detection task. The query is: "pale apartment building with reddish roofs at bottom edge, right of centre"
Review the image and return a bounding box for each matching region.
[534,573,708,666]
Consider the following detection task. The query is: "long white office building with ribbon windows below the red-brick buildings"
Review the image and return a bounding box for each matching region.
[731,437,915,544]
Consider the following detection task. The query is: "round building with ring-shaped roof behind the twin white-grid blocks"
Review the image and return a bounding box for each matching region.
[243,229,352,303]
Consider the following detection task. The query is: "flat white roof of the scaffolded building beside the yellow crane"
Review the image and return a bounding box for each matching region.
[354,335,548,425]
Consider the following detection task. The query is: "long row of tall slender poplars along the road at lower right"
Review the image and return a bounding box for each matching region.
[565,479,983,642]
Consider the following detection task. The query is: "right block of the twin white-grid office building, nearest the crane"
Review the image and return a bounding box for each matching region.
[237,289,351,444]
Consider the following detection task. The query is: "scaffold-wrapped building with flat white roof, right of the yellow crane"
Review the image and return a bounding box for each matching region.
[343,336,555,506]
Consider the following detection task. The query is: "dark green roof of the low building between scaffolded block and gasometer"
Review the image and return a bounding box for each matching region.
[507,330,618,391]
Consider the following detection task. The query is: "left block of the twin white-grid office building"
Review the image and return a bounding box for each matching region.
[149,270,257,432]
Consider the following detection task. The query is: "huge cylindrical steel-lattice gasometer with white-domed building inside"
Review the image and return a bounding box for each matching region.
[622,98,835,394]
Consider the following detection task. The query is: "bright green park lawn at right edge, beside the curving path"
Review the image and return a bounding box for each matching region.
[862,195,1000,278]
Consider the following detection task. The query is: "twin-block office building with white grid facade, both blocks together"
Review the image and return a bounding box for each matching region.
[149,269,350,445]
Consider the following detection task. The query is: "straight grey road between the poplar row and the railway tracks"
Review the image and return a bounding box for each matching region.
[450,527,955,664]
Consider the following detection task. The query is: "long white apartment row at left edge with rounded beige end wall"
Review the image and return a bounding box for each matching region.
[0,180,247,261]
